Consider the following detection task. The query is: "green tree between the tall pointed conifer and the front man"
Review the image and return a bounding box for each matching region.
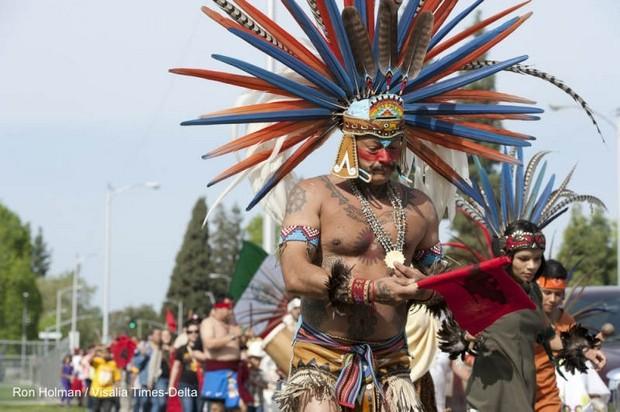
[209,205,242,282]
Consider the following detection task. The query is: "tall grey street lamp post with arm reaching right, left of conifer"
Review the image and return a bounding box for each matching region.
[101,182,159,344]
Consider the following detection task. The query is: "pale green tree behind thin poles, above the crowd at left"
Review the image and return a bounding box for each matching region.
[37,271,101,347]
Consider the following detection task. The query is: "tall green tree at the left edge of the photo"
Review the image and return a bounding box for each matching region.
[0,204,41,339]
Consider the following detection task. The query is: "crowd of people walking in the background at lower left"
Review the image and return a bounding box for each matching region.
[55,298,299,412]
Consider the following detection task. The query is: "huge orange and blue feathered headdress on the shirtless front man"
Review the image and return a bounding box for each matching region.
[171,0,600,209]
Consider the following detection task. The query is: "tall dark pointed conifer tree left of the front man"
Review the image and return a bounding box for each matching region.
[166,197,226,315]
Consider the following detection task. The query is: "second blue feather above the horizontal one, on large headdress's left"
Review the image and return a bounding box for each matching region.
[229,28,347,99]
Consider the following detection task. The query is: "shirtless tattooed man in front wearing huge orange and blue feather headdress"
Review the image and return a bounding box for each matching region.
[172,0,604,411]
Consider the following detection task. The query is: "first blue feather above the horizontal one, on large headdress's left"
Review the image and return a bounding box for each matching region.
[211,54,340,109]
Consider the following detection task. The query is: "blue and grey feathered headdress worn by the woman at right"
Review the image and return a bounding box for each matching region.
[457,149,605,238]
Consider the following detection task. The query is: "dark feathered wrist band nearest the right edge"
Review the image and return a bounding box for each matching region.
[557,324,600,374]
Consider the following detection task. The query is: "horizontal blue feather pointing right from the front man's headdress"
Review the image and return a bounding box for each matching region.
[405,103,544,116]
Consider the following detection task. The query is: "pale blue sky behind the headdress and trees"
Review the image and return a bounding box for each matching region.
[0,0,620,309]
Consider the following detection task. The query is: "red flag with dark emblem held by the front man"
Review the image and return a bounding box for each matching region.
[418,256,536,335]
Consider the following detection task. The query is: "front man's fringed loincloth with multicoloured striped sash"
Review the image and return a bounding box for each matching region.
[274,324,422,412]
